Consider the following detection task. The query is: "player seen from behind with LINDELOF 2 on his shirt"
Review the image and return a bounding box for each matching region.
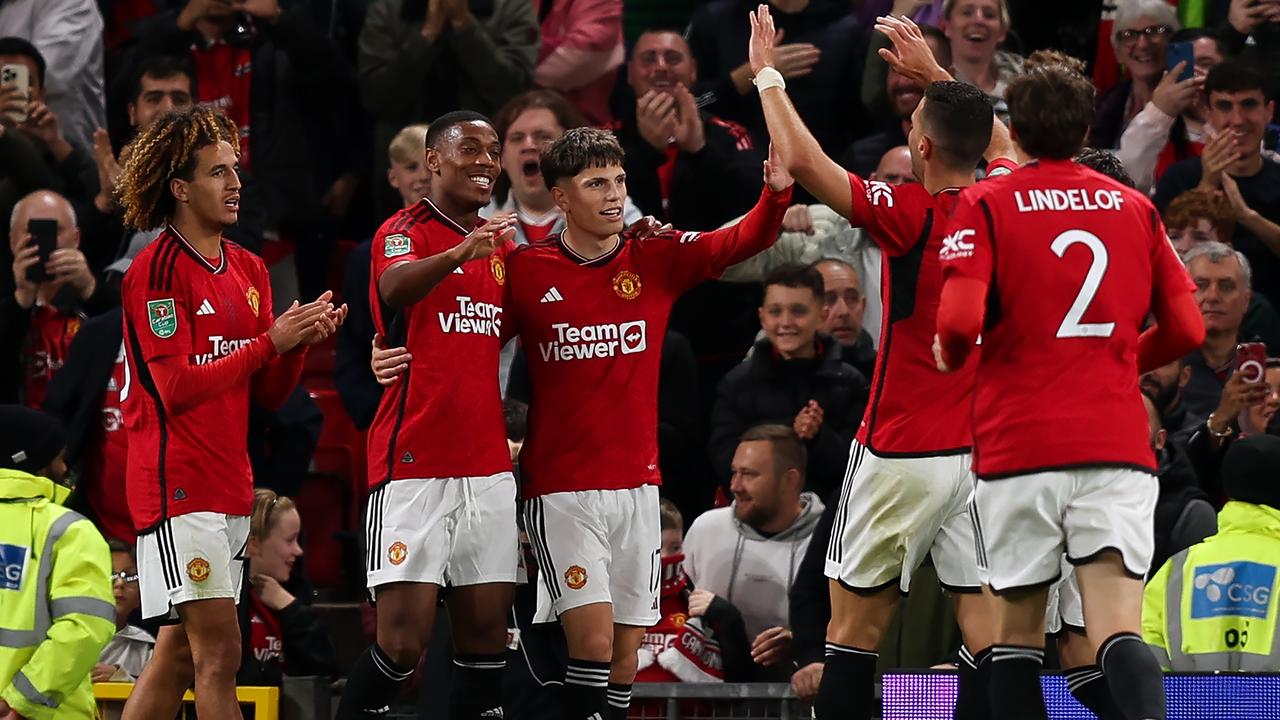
[934,65,1204,719]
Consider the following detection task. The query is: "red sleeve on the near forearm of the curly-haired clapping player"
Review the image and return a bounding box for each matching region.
[151,333,276,415]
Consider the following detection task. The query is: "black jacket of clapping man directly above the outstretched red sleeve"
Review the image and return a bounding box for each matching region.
[617,113,765,231]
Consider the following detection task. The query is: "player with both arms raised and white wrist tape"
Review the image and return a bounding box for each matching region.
[749,5,1015,720]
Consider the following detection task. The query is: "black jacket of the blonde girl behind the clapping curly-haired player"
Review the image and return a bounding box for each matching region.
[236,564,338,687]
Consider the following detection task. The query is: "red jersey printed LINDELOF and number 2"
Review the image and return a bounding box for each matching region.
[940,160,1194,479]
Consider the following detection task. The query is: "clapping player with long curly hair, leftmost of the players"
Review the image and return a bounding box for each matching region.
[116,106,347,720]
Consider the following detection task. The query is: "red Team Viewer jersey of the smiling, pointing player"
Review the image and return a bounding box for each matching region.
[369,199,511,487]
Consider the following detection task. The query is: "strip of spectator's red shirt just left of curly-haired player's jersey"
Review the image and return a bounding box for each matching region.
[84,342,137,544]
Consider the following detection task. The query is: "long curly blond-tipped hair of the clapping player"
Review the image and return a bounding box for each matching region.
[115,105,239,231]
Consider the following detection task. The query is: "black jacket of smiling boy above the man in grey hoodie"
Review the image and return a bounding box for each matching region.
[710,333,867,497]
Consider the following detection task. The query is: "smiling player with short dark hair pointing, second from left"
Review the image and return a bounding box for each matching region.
[338,111,518,720]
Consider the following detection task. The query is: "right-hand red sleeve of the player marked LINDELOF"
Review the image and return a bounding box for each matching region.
[1138,214,1204,373]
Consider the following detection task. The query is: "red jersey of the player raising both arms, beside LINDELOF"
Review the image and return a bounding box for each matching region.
[849,173,977,457]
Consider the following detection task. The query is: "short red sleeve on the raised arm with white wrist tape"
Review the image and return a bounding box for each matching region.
[849,173,932,256]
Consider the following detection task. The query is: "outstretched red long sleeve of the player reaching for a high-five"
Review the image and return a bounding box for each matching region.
[660,186,792,292]
